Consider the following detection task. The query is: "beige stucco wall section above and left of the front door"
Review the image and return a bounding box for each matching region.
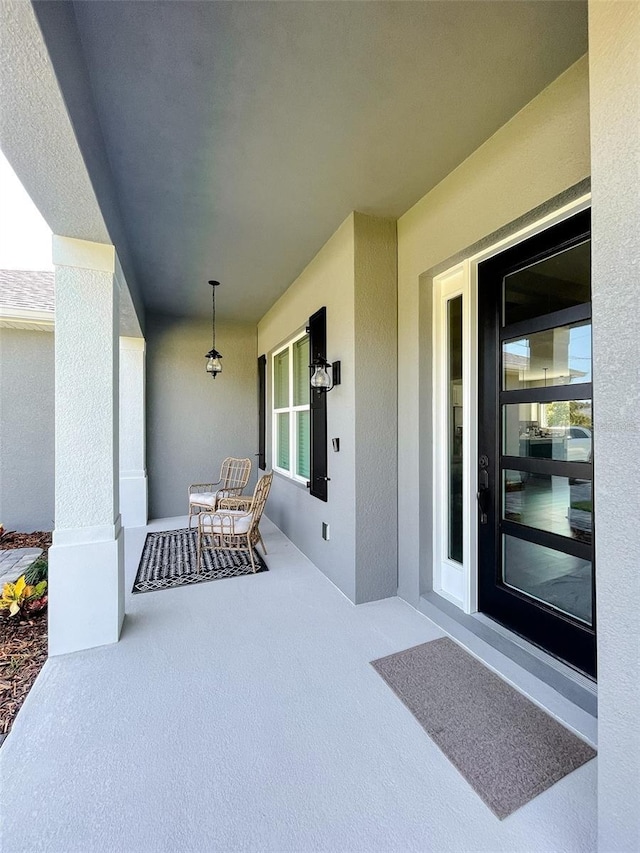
[398,56,590,605]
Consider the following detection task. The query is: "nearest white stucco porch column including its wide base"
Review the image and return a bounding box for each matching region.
[49,236,124,655]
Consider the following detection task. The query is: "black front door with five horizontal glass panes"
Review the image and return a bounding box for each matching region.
[478,211,596,677]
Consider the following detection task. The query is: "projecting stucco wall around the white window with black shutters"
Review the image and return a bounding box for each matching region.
[258,213,397,603]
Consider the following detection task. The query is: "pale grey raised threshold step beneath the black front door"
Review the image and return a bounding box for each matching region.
[418,592,598,747]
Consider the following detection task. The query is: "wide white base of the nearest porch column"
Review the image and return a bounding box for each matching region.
[49,518,124,655]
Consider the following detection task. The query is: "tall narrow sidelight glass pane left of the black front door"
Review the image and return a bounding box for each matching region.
[447,296,462,563]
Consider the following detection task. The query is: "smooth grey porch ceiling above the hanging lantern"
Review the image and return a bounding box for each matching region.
[41,0,587,320]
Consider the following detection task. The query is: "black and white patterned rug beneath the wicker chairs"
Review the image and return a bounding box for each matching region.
[132,528,268,592]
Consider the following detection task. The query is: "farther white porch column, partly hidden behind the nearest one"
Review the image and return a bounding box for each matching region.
[120,337,147,527]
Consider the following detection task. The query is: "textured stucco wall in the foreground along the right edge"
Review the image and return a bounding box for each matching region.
[589,2,640,853]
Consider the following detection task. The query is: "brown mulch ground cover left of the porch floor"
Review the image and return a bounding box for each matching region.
[0,530,51,744]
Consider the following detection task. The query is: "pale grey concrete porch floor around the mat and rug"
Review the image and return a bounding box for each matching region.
[0,519,596,853]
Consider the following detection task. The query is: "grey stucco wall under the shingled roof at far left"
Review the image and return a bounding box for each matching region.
[0,328,54,532]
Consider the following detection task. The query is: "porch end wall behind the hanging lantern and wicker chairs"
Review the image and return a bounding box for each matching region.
[146,315,258,518]
